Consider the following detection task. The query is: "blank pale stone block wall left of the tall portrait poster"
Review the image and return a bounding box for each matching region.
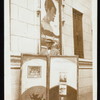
[10,0,40,54]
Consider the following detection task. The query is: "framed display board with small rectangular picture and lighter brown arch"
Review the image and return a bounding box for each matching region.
[21,54,47,100]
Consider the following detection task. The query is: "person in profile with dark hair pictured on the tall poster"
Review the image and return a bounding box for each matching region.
[41,0,59,55]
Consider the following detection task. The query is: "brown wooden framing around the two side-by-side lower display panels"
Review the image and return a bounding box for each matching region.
[21,54,79,100]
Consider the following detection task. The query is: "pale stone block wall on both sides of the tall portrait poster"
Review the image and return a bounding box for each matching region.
[10,0,92,59]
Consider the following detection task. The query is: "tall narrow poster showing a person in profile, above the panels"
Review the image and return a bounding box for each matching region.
[40,0,60,55]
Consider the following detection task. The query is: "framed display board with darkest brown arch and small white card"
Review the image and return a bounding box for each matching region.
[49,56,78,100]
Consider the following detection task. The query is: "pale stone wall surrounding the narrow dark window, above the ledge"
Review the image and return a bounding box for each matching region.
[62,0,92,59]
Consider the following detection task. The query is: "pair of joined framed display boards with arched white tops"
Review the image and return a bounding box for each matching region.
[21,54,78,100]
